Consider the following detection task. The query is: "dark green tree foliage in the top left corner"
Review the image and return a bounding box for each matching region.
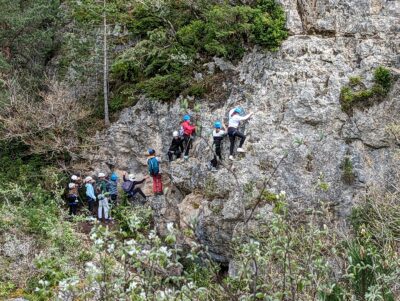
[0,0,60,90]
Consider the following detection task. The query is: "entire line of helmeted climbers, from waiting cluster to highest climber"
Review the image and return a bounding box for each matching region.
[67,108,253,218]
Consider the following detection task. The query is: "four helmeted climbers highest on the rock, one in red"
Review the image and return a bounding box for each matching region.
[168,107,253,171]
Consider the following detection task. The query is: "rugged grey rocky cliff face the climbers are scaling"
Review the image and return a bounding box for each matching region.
[88,0,400,262]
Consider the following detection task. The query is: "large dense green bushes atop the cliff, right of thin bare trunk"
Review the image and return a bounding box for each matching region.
[111,0,287,101]
